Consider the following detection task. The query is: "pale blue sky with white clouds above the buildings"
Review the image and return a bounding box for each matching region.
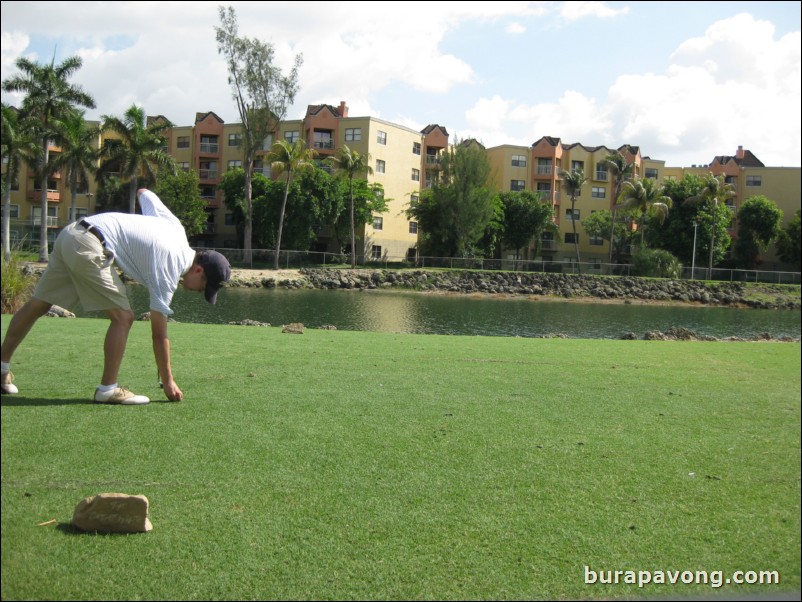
[0,0,802,167]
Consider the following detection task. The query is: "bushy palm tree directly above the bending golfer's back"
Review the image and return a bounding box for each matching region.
[100,105,176,213]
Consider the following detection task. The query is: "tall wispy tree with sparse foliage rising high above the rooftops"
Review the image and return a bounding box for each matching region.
[215,6,303,265]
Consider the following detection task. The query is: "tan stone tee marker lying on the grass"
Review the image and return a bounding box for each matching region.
[72,493,153,533]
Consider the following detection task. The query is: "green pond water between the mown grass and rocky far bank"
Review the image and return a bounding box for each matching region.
[79,285,801,339]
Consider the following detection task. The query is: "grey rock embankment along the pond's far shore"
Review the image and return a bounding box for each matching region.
[228,268,802,310]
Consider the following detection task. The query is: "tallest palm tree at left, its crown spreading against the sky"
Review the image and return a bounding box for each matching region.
[3,56,95,261]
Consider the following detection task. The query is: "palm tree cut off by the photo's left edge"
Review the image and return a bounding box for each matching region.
[2,103,38,262]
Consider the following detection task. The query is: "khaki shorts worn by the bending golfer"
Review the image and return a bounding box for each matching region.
[33,223,131,311]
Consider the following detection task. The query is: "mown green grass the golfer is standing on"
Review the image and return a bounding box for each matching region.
[2,316,800,600]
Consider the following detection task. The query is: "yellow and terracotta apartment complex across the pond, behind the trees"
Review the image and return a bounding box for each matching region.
[3,102,802,269]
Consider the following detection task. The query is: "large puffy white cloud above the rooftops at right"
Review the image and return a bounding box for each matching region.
[465,15,802,166]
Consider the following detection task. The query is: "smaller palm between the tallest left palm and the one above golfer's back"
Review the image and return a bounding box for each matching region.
[53,111,100,221]
